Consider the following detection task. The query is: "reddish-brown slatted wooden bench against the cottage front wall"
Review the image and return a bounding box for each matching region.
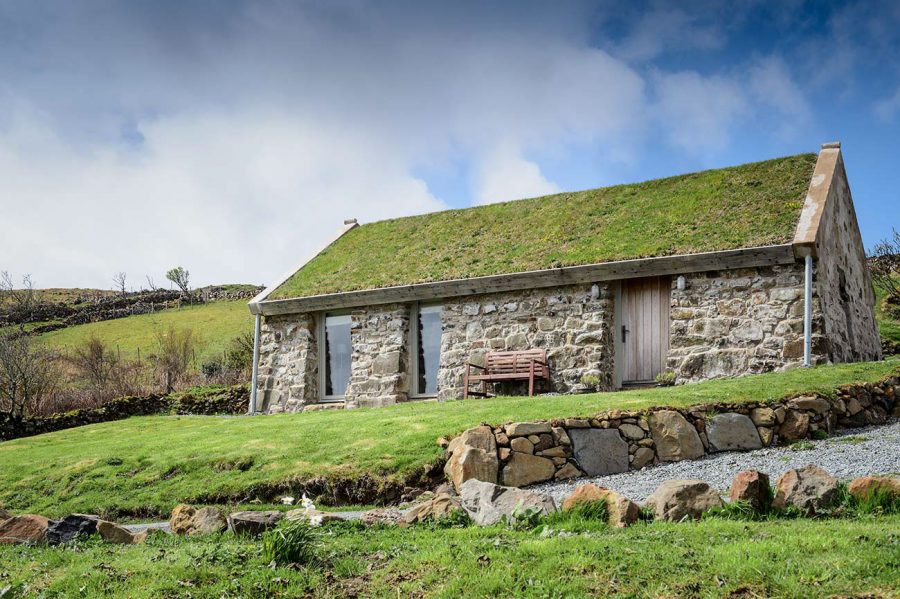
[463,349,550,399]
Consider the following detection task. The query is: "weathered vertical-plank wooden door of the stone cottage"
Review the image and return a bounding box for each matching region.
[618,277,672,383]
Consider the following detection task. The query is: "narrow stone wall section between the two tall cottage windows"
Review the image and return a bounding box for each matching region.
[346,304,410,408]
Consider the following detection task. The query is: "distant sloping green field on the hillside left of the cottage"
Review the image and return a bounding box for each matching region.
[39,300,253,360]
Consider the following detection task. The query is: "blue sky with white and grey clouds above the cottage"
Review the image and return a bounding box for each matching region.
[0,0,900,288]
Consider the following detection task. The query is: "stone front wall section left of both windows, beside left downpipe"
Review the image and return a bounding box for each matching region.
[257,314,319,414]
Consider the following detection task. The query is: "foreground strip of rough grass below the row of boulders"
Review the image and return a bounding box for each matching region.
[0,516,900,598]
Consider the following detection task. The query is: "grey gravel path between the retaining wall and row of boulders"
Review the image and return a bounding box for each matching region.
[530,421,900,505]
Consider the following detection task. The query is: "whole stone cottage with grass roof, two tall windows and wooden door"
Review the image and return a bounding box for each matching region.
[250,143,881,413]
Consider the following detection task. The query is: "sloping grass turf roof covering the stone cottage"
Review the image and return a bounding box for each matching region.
[268,154,816,299]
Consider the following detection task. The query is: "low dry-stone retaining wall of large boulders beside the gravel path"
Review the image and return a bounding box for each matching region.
[445,376,900,487]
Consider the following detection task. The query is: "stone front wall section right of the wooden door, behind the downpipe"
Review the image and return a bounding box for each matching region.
[668,263,828,382]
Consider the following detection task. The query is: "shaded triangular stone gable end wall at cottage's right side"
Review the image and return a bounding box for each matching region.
[815,157,881,362]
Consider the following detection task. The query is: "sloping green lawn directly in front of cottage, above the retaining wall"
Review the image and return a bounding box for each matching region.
[0,358,900,516]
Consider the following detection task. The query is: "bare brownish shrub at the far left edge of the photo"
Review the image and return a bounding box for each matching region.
[0,332,62,420]
